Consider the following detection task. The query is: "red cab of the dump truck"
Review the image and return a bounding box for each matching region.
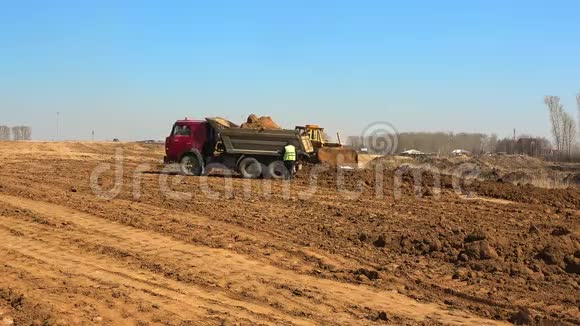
[164,118,212,163]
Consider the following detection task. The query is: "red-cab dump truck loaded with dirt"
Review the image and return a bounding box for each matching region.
[164,118,314,179]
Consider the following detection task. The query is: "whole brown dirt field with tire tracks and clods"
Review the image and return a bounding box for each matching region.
[0,142,580,325]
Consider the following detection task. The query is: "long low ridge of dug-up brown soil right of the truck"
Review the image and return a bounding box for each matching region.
[298,160,580,210]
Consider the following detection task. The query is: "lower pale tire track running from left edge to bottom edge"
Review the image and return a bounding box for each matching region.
[0,225,307,325]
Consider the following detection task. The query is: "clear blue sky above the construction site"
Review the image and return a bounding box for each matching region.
[0,0,580,139]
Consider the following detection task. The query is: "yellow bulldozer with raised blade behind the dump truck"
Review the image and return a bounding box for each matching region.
[296,125,358,167]
